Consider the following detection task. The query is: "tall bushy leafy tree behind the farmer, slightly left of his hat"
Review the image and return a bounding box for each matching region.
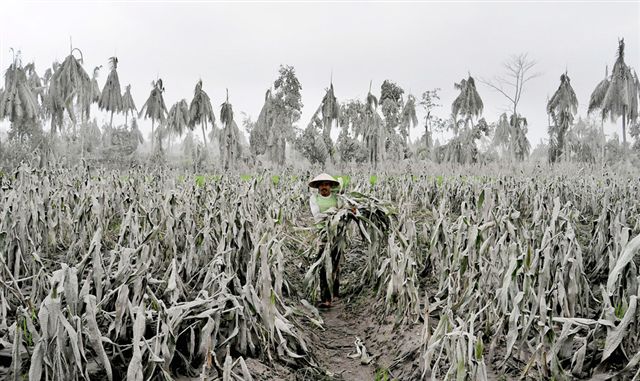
[267,65,303,165]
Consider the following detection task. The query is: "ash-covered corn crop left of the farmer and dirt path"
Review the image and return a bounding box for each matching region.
[0,167,314,380]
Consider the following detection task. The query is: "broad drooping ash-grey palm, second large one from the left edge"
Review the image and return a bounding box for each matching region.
[47,47,91,134]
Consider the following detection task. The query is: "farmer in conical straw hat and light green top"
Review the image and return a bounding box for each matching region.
[309,173,354,308]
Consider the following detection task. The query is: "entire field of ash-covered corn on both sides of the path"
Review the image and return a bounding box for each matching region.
[0,166,640,380]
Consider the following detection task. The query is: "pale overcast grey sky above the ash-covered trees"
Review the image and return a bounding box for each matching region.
[0,0,640,146]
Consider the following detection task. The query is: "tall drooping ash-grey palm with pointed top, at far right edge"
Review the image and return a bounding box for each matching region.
[589,39,638,147]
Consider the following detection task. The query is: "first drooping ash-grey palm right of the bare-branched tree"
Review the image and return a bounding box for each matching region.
[547,72,578,163]
